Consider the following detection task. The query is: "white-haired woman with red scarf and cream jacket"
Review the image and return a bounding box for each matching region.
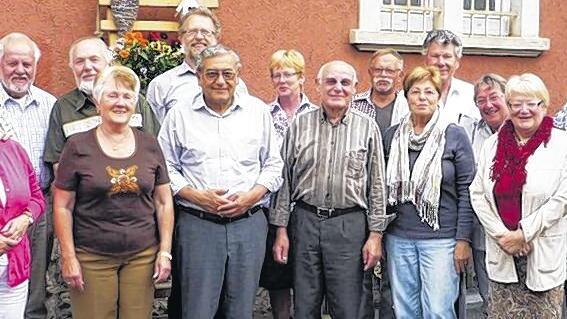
[470,73,567,318]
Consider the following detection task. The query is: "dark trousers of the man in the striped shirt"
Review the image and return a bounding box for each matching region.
[290,206,373,319]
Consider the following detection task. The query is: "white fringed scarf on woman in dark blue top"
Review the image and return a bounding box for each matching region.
[386,109,448,231]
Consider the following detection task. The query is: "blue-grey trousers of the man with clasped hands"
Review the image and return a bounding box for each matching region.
[174,212,267,319]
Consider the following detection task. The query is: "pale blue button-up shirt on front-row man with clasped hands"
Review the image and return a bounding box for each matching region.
[158,94,283,209]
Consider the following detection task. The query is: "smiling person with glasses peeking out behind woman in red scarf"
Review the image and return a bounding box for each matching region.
[461,73,509,317]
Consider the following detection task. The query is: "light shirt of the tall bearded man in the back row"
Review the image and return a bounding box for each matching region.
[146,62,248,123]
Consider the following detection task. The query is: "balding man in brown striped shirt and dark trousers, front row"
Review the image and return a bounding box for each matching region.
[270,61,389,319]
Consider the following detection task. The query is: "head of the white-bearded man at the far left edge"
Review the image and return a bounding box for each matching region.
[0,32,41,98]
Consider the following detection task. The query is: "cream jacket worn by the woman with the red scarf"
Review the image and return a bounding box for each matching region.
[470,129,567,291]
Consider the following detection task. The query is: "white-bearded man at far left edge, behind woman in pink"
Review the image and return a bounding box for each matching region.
[0,32,55,318]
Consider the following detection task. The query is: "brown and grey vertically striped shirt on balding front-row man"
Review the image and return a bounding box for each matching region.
[270,108,389,231]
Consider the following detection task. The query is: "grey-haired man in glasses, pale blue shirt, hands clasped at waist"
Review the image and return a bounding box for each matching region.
[158,45,283,319]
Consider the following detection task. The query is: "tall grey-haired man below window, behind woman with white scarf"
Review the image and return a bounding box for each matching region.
[423,30,480,124]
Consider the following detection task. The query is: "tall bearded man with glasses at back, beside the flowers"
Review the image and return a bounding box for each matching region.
[146,7,248,123]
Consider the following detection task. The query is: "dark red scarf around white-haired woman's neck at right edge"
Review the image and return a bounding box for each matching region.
[490,116,553,230]
